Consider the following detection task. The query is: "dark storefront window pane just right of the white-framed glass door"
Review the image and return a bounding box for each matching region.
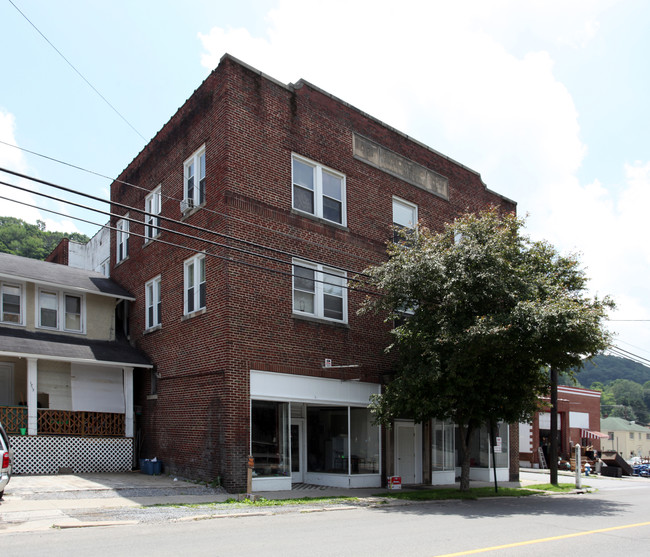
[307,406,350,474]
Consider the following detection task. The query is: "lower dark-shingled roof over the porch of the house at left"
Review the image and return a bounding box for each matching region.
[0,327,153,368]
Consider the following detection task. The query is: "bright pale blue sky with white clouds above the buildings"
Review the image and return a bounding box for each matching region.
[0,0,650,359]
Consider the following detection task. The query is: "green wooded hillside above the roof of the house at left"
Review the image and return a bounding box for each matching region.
[0,217,90,259]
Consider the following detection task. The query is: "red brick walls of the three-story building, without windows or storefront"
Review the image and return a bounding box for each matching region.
[111,57,515,489]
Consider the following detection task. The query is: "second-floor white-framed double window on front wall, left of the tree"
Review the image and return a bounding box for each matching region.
[293,260,348,323]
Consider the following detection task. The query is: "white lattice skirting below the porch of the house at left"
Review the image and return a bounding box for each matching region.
[10,435,133,474]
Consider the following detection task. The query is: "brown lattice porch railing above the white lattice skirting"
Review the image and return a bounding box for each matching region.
[0,406,126,437]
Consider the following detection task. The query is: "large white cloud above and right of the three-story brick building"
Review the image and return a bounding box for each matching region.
[200,0,650,352]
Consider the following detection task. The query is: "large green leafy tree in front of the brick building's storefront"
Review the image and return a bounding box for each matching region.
[362,209,613,490]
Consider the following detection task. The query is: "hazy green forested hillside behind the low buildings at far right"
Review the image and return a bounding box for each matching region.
[564,355,650,424]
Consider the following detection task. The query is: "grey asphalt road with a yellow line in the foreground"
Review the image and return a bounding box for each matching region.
[0,478,650,557]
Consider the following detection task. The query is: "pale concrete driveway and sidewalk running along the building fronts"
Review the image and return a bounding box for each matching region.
[0,470,650,534]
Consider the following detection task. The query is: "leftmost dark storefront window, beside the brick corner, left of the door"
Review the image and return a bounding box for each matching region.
[251,400,289,477]
